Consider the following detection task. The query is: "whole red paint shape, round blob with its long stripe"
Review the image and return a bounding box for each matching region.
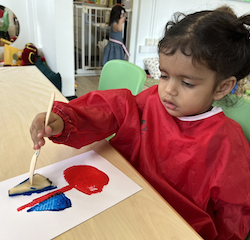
[17,165,109,211]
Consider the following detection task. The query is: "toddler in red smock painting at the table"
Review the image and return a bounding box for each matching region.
[30,7,250,240]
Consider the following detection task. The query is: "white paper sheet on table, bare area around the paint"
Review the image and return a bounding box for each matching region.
[0,151,141,240]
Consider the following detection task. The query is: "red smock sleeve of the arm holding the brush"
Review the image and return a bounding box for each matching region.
[43,89,140,148]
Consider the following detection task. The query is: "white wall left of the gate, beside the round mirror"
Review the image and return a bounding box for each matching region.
[0,0,75,96]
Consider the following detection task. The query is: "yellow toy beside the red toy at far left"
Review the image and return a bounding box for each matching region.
[4,44,23,66]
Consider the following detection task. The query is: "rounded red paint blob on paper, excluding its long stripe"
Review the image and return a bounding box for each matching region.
[64,165,109,195]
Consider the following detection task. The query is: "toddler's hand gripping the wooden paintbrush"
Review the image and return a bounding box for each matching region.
[30,113,64,150]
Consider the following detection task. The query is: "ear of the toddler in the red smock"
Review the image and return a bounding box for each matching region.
[214,76,237,100]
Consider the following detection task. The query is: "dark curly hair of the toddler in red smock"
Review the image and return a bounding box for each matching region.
[158,6,250,82]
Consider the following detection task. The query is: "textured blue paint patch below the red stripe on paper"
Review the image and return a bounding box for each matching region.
[27,193,72,212]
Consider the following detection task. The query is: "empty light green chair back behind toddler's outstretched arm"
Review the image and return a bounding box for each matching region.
[98,59,147,95]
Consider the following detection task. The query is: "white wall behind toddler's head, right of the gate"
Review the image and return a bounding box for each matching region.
[133,0,250,69]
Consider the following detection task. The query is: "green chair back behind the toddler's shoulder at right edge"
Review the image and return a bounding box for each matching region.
[214,94,250,144]
